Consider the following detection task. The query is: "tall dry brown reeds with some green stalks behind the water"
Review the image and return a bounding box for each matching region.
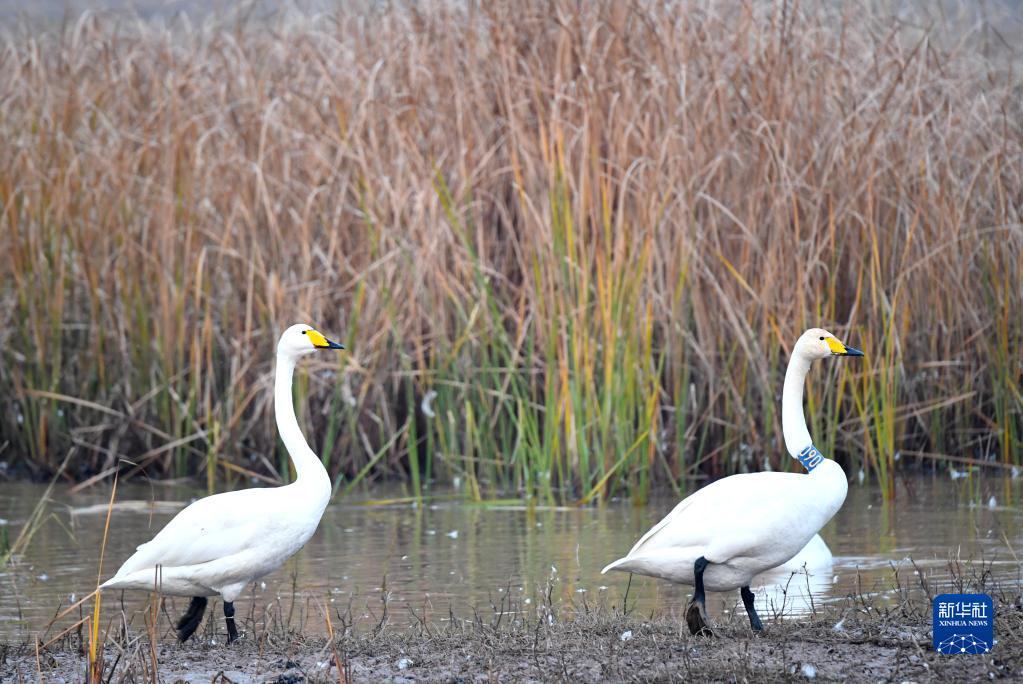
[0,0,1023,501]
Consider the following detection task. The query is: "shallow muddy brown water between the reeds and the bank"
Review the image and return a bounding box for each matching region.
[0,475,1023,639]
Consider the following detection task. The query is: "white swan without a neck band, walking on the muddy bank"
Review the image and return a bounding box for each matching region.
[100,324,345,643]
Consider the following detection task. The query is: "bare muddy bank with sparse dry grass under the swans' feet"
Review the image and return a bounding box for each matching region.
[0,595,1023,684]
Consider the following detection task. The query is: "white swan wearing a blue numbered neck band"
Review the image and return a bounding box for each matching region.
[602,328,863,635]
